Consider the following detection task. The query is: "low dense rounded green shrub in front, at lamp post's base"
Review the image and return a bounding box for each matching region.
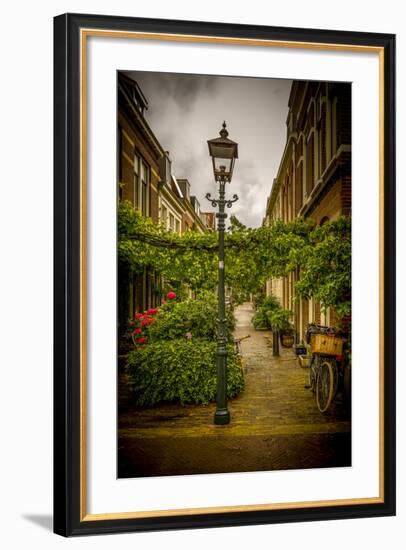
[126,338,244,407]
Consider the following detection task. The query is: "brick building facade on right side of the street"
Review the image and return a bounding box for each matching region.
[263,81,351,338]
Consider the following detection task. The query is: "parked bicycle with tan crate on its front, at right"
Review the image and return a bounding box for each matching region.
[306,323,344,413]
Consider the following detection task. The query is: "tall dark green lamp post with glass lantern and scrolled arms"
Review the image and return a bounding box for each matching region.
[206,122,238,425]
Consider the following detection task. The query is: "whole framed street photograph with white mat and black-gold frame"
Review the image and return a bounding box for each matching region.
[54,14,395,536]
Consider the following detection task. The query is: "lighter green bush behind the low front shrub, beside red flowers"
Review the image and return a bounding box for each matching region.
[148,293,234,343]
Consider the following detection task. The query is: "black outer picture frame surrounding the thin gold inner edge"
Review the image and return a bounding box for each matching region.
[54,14,395,536]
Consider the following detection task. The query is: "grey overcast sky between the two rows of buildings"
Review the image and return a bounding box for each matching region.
[129,71,292,227]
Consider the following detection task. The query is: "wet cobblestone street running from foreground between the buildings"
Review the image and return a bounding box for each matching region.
[118,303,351,477]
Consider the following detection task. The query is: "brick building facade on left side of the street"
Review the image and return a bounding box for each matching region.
[117,73,208,327]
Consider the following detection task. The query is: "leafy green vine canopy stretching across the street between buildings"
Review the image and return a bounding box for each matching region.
[118,202,351,315]
